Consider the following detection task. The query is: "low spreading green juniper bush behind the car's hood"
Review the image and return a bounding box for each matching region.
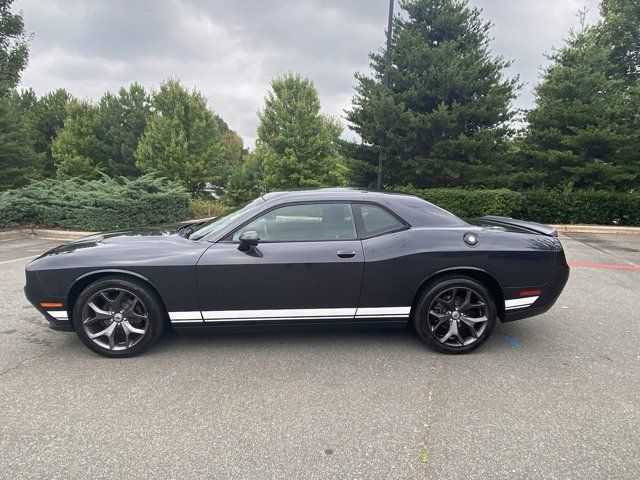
[0,175,189,230]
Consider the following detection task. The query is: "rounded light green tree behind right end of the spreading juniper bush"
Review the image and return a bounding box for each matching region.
[136,80,222,190]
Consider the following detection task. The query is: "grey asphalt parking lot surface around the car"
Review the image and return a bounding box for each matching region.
[0,234,640,479]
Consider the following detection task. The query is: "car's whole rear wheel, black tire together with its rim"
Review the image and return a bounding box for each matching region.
[413,275,497,354]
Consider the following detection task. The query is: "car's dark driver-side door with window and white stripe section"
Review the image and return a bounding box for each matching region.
[197,202,364,324]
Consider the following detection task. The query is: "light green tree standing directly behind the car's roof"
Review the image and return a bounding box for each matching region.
[255,73,347,189]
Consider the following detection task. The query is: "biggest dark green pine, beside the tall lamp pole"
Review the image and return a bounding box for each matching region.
[347,0,517,187]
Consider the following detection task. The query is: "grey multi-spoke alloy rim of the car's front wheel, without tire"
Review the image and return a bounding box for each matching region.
[82,287,149,351]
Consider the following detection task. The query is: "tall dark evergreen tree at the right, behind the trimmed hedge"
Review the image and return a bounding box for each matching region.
[523,15,640,190]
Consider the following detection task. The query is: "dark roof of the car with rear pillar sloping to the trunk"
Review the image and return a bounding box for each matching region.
[262,188,467,227]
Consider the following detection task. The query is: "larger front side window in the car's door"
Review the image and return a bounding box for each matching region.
[227,203,357,242]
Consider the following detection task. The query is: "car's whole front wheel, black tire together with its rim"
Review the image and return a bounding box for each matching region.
[73,276,166,358]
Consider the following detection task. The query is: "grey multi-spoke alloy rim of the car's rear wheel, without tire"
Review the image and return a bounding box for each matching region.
[427,287,489,347]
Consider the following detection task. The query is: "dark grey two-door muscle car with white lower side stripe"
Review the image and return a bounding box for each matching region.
[25,189,569,357]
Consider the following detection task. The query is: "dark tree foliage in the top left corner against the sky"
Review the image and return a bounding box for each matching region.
[0,0,29,97]
